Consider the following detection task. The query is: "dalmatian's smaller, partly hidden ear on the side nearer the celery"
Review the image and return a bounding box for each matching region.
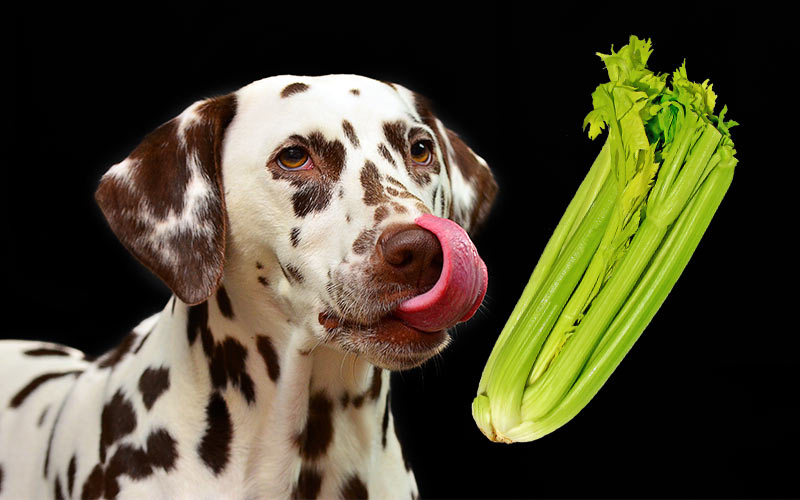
[414,94,497,236]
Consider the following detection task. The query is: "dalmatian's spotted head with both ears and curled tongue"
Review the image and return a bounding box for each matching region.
[96,75,497,368]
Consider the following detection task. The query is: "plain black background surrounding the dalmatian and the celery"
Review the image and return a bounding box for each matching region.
[9,2,800,498]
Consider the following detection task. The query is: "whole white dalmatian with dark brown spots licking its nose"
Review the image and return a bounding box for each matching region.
[0,75,497,499]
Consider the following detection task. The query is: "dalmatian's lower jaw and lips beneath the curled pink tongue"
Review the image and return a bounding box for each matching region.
[319,311,450,370]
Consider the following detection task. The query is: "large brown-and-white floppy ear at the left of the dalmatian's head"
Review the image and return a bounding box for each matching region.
[95,94,236,304]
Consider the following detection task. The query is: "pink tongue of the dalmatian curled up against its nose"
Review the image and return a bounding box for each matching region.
[395,214,488,332]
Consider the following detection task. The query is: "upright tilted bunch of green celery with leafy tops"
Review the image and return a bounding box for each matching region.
[472,36,736,443]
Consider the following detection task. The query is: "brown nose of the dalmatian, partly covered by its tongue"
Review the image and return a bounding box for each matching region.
[377,224,443,293]
